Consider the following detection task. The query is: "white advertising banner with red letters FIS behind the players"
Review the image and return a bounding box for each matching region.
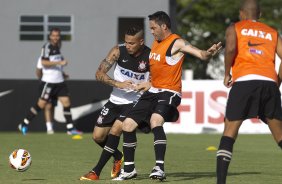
[164,80,270,133]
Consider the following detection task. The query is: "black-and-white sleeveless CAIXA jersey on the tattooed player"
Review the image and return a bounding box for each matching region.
[110,45,150,104]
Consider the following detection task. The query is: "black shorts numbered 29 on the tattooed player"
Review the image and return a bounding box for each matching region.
[96,101,133,127]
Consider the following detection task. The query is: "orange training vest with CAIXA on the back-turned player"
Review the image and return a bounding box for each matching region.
[232,20,278,81]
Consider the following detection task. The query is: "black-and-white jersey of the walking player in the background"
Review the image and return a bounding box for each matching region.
[37,42,64,83]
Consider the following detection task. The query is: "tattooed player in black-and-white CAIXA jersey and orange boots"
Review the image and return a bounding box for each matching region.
[80,27,150,180]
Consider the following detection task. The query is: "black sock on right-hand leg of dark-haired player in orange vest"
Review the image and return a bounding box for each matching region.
[152,126,166,171]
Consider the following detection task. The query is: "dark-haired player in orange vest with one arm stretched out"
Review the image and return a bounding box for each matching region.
[114,11,221,180]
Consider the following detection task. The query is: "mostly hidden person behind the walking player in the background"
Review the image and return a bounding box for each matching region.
[36,57,57,134]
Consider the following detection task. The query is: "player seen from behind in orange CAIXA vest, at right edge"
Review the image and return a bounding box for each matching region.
[216,0,282,184]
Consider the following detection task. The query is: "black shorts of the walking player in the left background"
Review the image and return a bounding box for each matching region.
[39,81,69,102]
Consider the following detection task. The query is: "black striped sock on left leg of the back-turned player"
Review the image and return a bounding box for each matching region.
[216,136,235,184]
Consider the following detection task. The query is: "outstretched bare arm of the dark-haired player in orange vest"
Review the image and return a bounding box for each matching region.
[171,39,221,60]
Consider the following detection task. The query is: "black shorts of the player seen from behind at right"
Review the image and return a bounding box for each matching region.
[225,80,282,123]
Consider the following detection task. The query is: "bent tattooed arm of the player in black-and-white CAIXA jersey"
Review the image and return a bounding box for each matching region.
[96,46,132,88]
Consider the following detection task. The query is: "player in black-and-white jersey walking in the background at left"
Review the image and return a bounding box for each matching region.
[18,28,82,135]
